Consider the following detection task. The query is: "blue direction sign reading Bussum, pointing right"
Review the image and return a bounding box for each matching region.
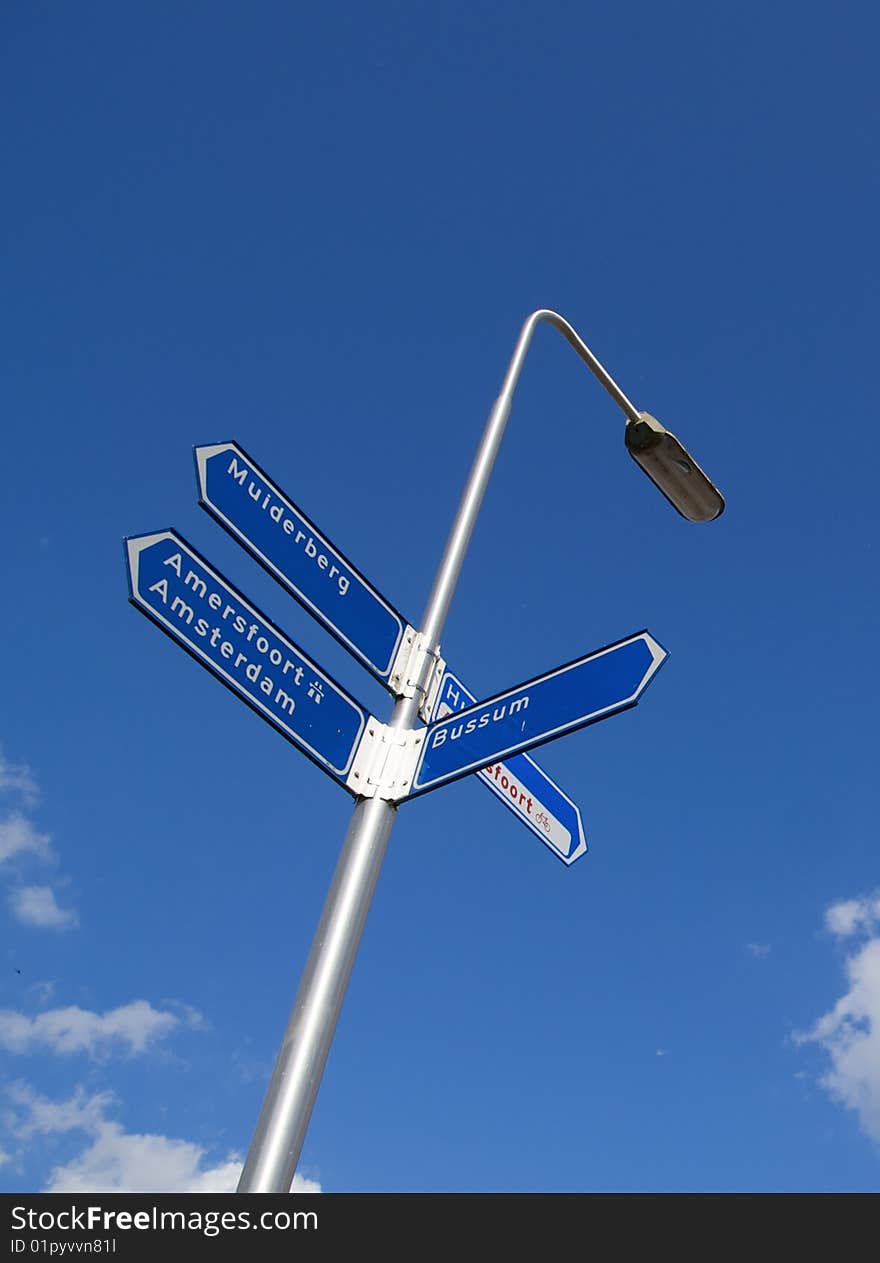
[412,632,667,794]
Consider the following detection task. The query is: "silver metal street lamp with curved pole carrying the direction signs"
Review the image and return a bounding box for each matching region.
[239,309,723,1192]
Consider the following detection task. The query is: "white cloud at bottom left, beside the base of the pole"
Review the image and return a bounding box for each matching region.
[10,1084,321,1192]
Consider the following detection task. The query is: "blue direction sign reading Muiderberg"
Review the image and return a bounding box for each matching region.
[196,443,407,685]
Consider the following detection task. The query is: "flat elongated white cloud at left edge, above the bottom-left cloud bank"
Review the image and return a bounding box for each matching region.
[0,1000,190,1057]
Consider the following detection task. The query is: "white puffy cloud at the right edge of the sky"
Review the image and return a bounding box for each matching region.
[794,897,880,1143]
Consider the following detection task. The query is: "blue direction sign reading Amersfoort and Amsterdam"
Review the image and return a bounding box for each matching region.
[125,530,369,784]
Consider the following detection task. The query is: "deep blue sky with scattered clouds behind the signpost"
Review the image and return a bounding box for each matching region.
[0,0,880,1192]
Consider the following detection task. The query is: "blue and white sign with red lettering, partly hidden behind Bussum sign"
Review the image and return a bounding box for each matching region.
[432,671,587,864]
